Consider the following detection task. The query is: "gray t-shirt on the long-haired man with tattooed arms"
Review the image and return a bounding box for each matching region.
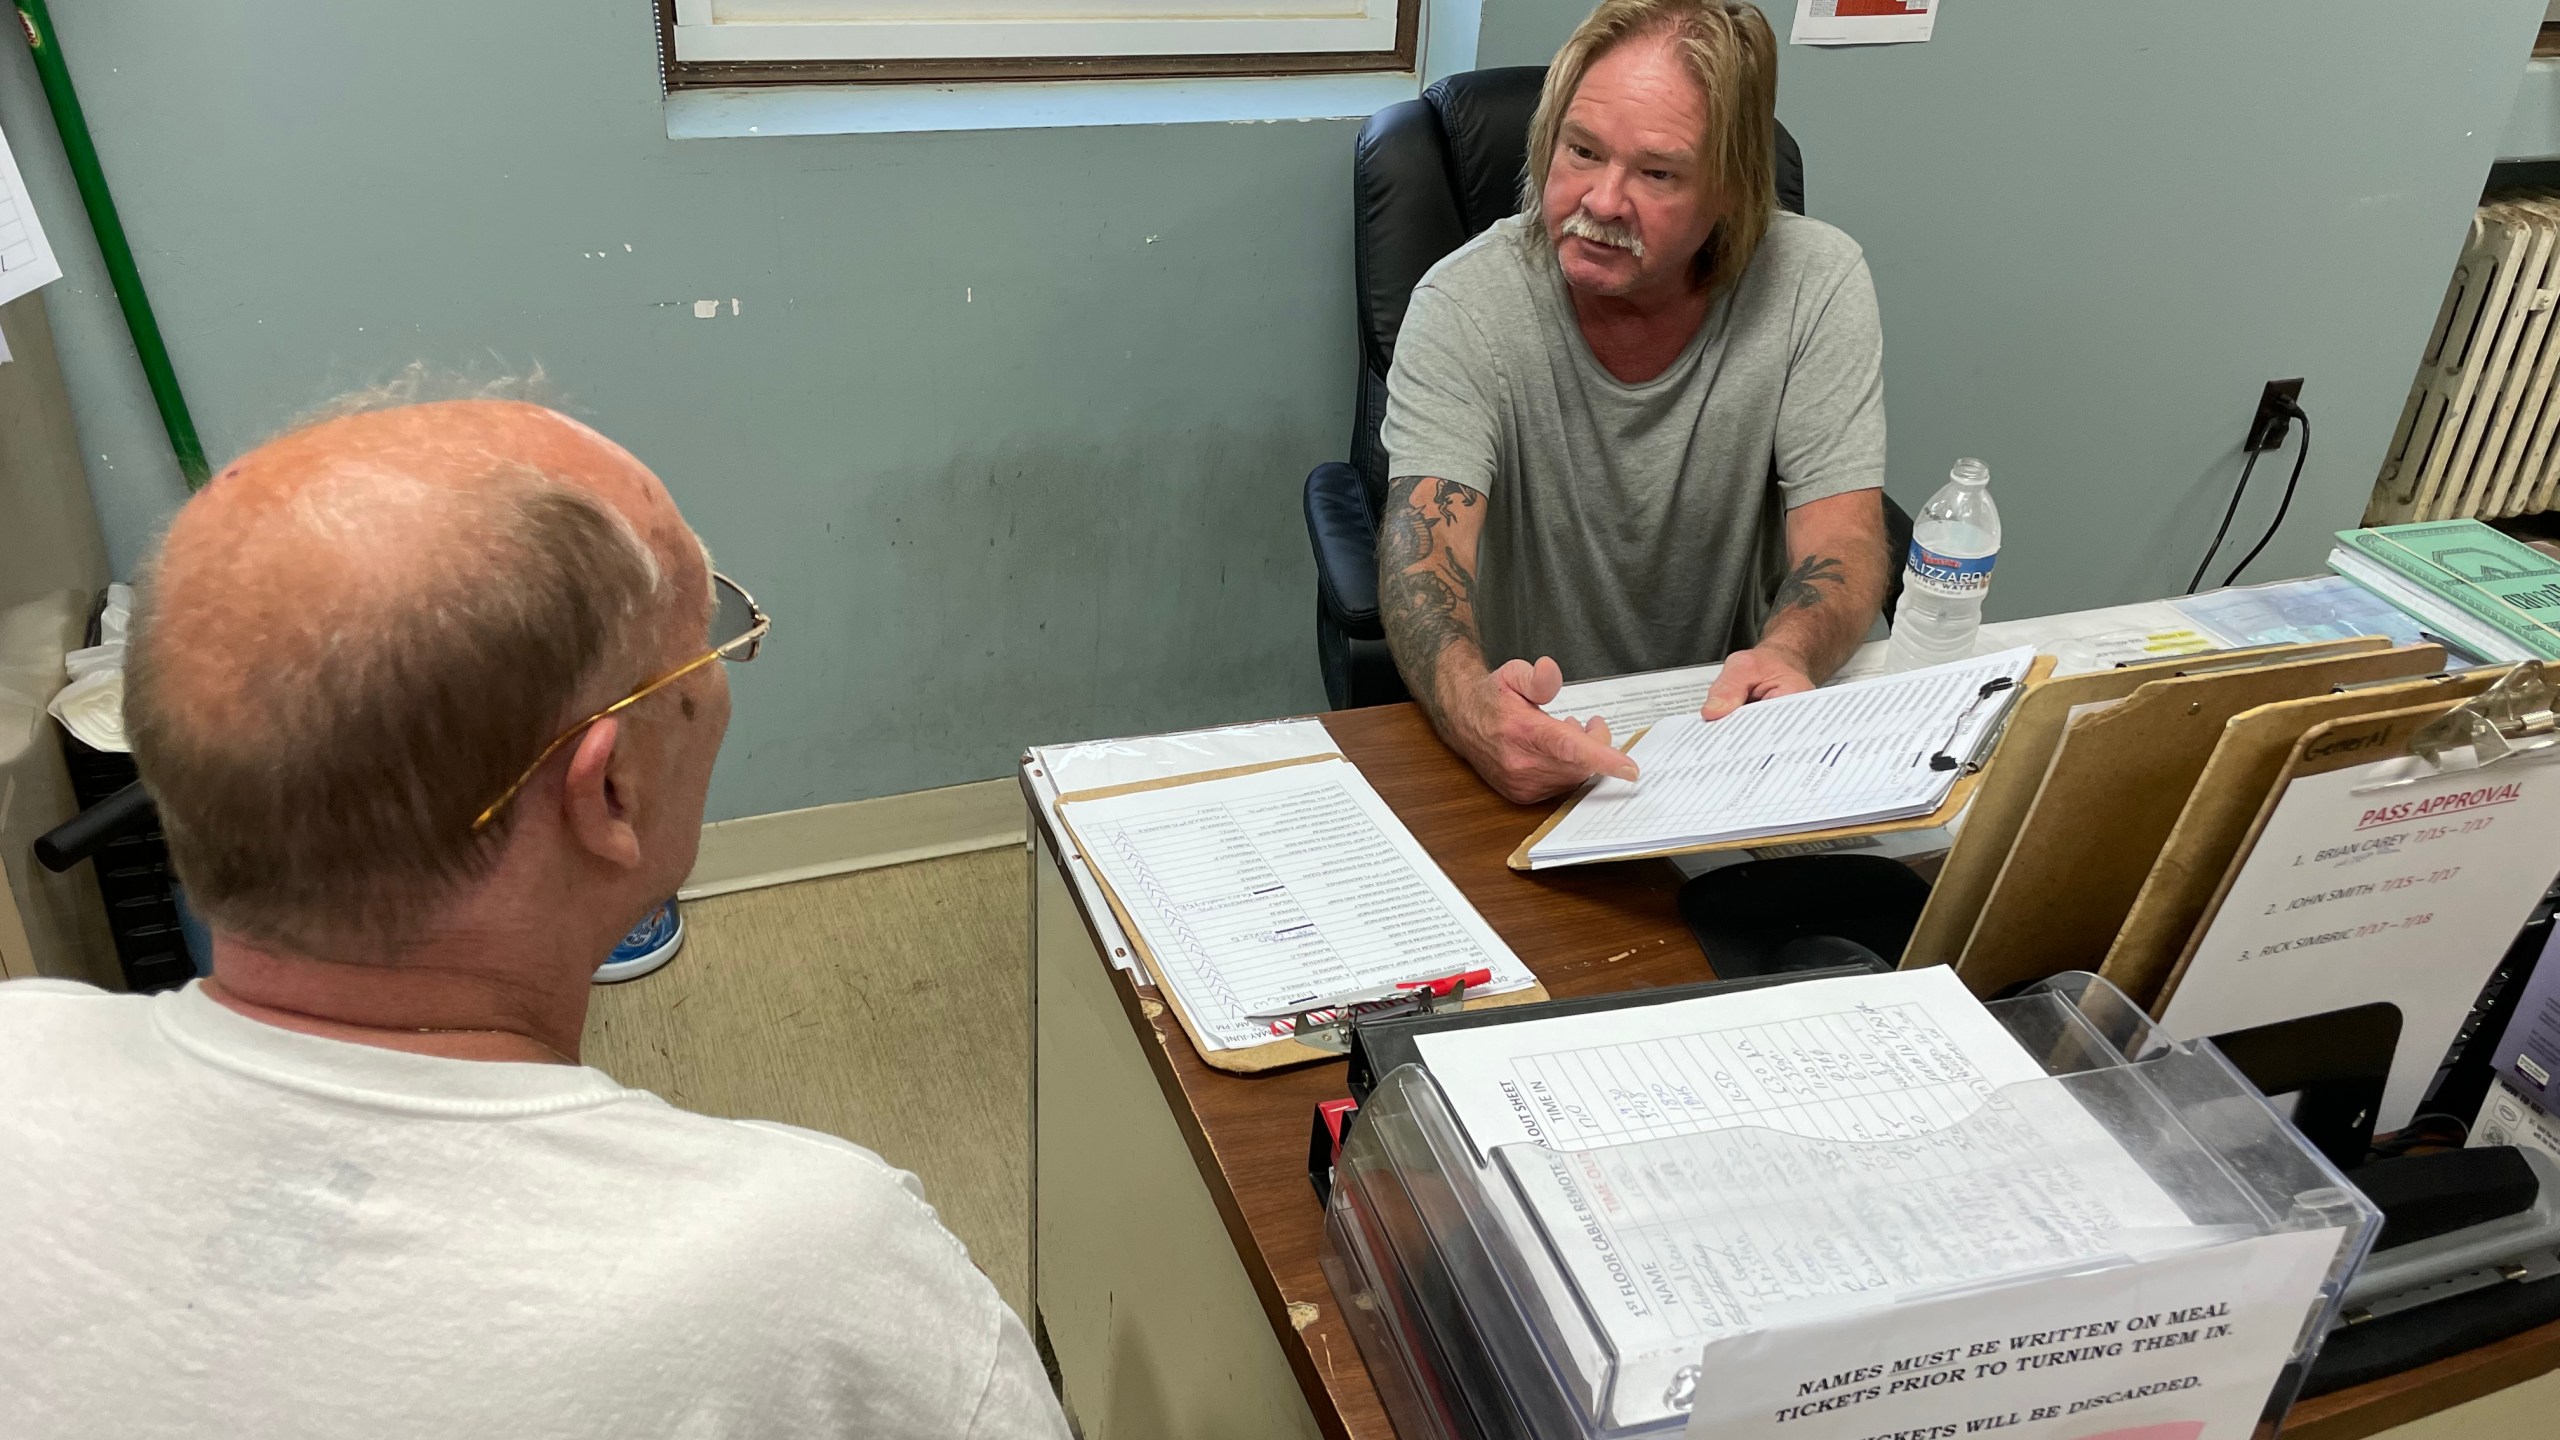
[1382,213,1884,679]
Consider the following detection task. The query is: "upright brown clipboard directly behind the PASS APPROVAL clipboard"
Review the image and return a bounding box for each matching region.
[2099,671,2504,1007]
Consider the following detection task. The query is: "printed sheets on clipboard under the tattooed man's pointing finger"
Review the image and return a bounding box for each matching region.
[1528,648,2035,869]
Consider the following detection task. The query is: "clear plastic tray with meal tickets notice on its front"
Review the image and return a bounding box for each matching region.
[1324,974,2381,1440]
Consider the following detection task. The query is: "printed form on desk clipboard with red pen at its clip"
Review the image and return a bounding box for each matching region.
[1057,758,1536,1051]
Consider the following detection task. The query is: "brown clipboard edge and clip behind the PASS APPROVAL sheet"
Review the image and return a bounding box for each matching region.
[2150,661,2560,1017]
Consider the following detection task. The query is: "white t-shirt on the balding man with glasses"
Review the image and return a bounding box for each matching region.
[0,981,1068,1440]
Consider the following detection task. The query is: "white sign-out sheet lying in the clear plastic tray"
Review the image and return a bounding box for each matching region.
[1418,966,2202,1425]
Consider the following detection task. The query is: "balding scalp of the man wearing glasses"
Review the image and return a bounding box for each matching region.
[125,400,709,951]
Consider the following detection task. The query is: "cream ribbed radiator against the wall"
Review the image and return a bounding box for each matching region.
[2365,195,2560,525]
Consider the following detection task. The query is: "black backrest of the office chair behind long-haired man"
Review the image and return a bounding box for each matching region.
[1352,64,1805,512]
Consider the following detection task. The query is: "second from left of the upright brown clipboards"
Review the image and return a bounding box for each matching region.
[1956,641,2445,994]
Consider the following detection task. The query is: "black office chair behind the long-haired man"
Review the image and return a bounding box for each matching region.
[1306,64,1910,710]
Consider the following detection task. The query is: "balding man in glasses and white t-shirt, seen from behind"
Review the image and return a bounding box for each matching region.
[0,400,1065,1440]
